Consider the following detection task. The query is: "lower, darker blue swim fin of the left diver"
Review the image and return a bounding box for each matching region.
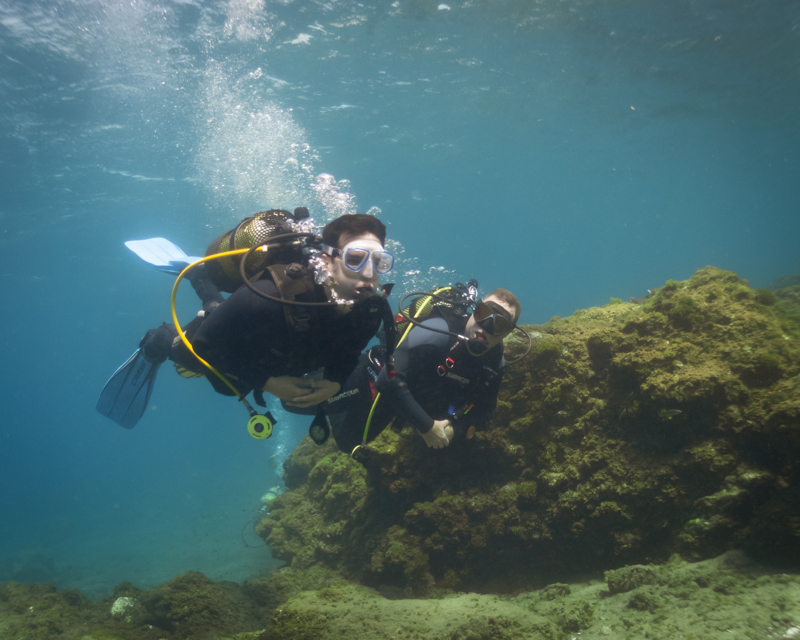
[97,349,161,429]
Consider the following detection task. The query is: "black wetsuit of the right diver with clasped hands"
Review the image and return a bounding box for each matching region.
[316,318,504,453]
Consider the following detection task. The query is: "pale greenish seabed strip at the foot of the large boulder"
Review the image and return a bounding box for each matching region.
[261,552,800,640]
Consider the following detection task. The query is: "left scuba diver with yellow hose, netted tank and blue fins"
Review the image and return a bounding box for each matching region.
[97,207,394,439]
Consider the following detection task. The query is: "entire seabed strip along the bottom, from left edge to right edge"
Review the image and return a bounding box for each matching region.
[0,552,800,640]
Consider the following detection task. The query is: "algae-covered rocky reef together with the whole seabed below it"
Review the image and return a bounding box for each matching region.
[0,267,800,640]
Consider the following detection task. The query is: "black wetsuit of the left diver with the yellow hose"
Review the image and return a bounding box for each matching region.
[173,278,381,395]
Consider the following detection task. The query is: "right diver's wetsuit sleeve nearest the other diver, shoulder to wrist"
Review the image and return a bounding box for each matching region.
[378,318,450,433]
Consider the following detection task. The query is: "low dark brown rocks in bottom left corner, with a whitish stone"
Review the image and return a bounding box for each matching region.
[0,568,343,640]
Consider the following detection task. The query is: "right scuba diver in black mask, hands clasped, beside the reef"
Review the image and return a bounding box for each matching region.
[284,280,530,452]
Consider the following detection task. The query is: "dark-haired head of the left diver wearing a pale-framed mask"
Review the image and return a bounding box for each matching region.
[322,213,394,300]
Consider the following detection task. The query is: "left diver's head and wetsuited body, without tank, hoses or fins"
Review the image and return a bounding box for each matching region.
[141,214,393,407]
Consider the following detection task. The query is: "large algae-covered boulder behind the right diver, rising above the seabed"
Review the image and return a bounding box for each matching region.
[258,267,800,596]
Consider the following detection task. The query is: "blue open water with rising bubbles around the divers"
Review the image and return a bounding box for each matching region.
[0,0,800,597]
